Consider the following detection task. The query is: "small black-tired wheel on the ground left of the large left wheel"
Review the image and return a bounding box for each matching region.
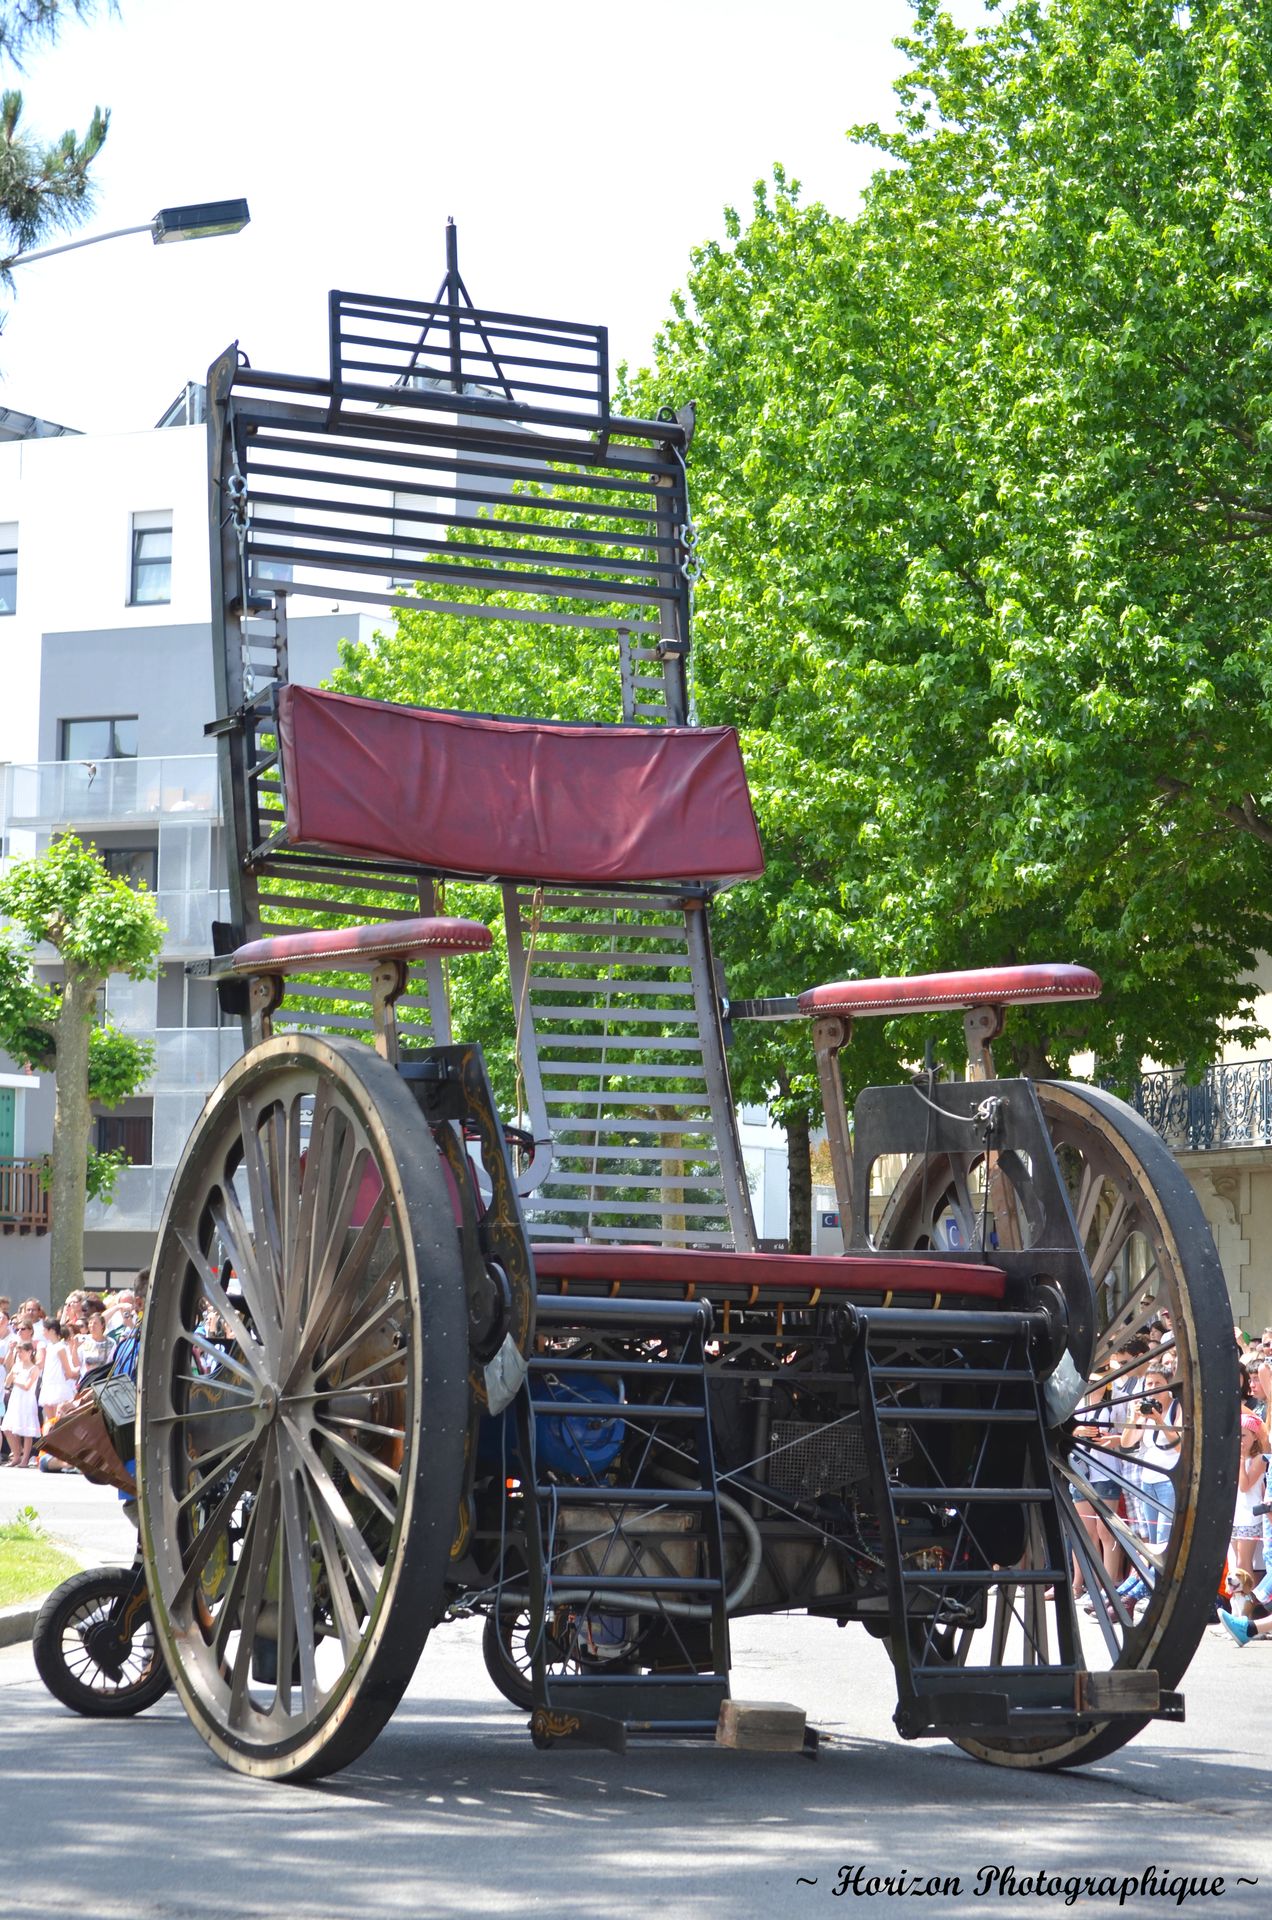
[31,1567,173,1720]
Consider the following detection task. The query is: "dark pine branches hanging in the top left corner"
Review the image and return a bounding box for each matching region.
[0,0,113,286]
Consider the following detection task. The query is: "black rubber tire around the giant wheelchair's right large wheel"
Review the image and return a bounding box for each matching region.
[878,1081,1239,1770]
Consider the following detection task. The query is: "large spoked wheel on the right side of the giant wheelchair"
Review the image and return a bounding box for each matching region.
[876,1081,1239,1768]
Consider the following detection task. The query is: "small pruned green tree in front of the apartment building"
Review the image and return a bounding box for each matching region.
[0,833,165,1300]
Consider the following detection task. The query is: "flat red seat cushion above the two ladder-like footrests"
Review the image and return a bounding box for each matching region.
[532,1240,1003,1300]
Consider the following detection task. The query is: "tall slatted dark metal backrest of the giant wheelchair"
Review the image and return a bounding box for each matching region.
[208,228,755,1246]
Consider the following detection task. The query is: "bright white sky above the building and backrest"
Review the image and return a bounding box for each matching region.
[0,0,980,432]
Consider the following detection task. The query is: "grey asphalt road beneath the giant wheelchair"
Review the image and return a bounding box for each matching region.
[0,1475,1272,1920]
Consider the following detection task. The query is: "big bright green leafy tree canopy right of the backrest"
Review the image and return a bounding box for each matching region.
[630,0,1272,1081]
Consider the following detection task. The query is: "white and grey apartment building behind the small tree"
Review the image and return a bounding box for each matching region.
[0,403,375,1298]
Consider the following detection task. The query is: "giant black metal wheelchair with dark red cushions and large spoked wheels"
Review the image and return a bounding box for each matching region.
[138,230,1235,1780]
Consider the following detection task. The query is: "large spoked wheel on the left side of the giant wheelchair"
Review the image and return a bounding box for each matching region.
[138,1035,469,1780]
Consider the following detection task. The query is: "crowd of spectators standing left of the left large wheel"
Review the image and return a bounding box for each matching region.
[0,1277,140,1473]
